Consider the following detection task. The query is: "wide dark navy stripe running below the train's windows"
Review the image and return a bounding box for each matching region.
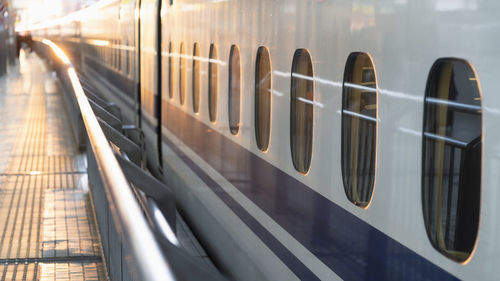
[153,102,457,280]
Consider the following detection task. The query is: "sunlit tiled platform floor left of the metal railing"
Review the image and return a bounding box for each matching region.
[0,51,106,281]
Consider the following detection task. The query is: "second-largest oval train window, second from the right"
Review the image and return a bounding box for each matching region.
[341,52,377,208]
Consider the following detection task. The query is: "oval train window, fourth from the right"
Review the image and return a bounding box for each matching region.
[255,46,272,151]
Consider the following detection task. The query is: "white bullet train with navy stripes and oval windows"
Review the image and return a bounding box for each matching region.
[20,0,500,280]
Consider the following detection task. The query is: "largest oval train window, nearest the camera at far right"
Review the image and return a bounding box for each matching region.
[422,59,482,262]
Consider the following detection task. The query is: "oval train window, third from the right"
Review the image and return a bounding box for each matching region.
[290,49,314,174]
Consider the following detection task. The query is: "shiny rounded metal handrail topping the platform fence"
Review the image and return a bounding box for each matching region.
[41,39,175,281]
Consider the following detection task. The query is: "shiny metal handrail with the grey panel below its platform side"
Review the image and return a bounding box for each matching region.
[38,39,176,281]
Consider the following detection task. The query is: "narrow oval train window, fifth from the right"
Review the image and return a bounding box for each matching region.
[228,45,241,135]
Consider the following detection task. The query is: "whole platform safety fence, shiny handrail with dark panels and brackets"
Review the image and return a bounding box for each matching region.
[34,38,224,281]
